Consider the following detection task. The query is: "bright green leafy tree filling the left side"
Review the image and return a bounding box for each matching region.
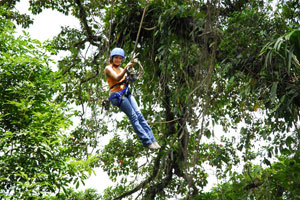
[0,8,95,199]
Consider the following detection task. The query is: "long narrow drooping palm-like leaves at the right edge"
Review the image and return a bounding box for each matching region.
[261,29,300,122]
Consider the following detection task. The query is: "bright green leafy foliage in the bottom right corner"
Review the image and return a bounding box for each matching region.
[206,157,300,200]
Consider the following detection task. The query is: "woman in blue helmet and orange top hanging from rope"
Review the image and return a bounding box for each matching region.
[104,48,160,150]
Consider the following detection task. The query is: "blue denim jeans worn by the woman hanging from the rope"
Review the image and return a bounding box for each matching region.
[111,94,156,146]
